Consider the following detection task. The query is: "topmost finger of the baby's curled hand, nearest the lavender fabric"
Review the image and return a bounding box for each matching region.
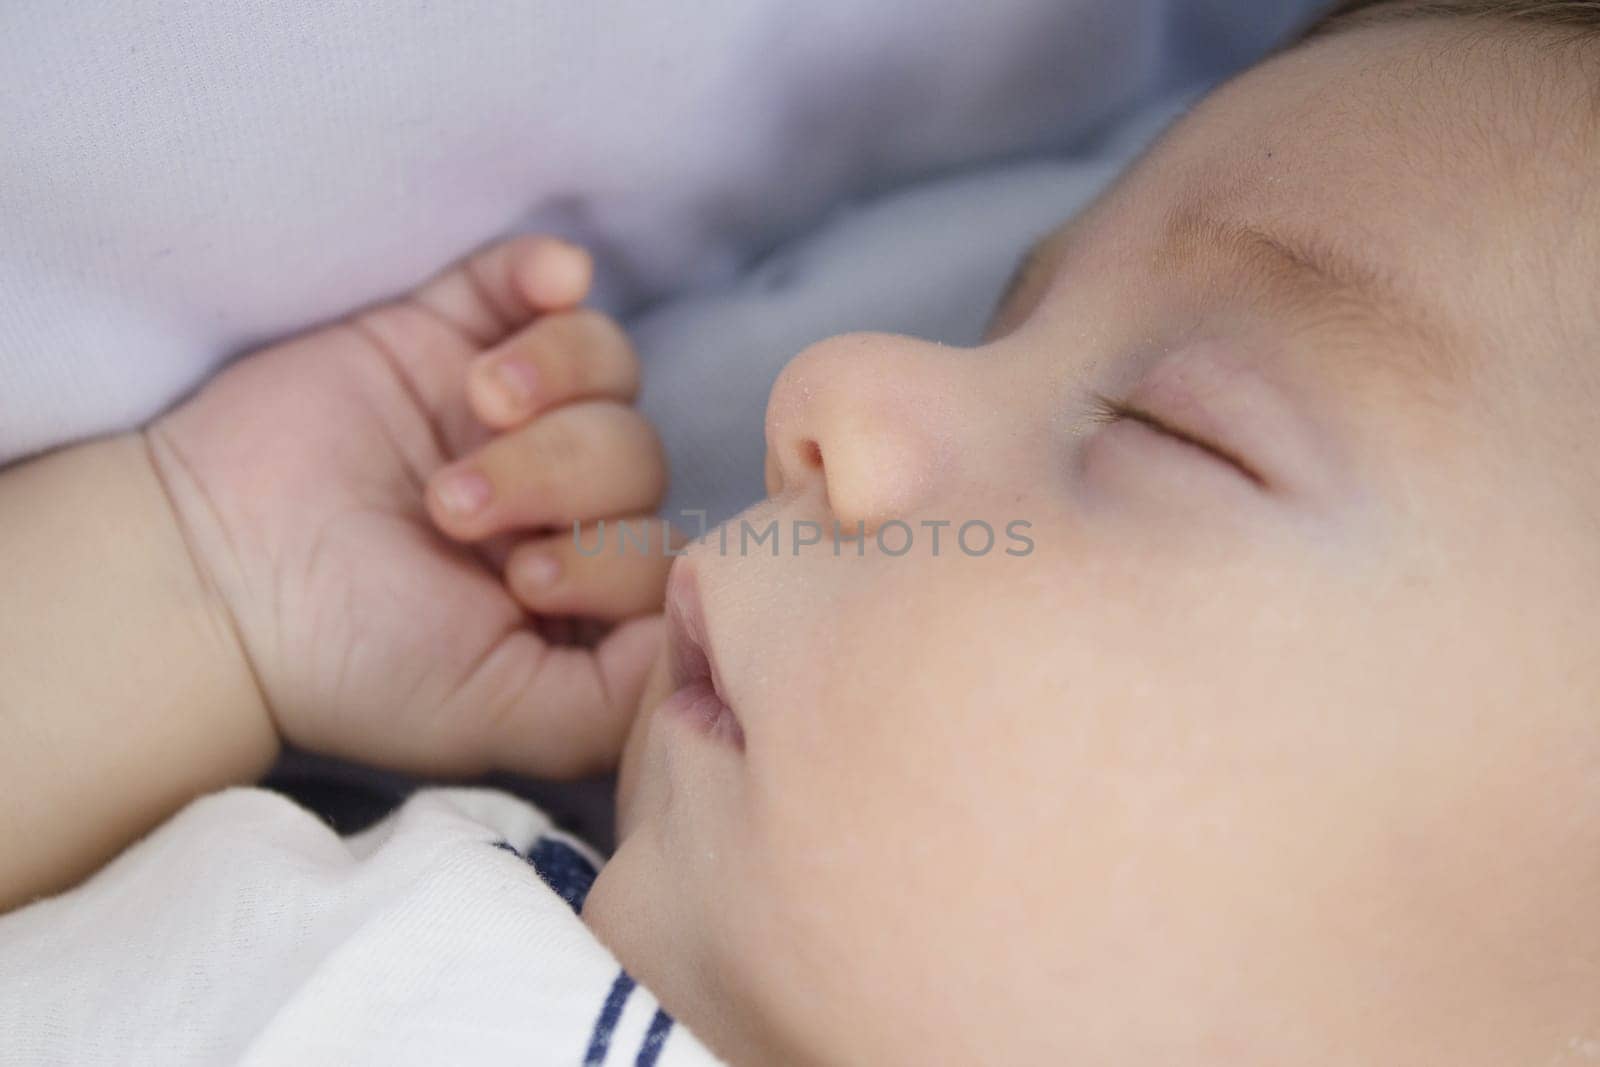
[411,235,594,346]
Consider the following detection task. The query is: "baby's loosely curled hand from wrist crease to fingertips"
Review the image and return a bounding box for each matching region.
[147,237,670,776]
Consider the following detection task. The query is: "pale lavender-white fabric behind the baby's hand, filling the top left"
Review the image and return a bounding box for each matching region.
[0,0,1317,464]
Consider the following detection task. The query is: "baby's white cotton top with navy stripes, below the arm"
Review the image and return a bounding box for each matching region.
[0,789,718,1067]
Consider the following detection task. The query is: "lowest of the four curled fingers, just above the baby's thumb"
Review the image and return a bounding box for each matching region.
[506,515,685,621]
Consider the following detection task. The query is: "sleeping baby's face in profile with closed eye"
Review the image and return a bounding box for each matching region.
[586,22,1600,1065]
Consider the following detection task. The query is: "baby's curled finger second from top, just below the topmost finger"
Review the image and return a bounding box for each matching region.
[467,307,638,430]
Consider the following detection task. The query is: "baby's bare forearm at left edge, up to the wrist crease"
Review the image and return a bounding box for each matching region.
[0,434,278,912]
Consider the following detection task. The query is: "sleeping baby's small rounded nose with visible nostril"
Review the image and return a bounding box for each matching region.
[766,333,966,530]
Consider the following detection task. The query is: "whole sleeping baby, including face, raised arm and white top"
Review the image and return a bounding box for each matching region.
[0,0,1600,1067]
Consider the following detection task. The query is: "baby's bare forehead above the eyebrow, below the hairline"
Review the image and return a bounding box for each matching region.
[1130,19,1600,396]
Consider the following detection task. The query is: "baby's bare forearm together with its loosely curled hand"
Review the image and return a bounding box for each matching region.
[0,234,666,904]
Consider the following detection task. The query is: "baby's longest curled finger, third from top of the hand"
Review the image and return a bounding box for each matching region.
[427,400,667,541]
